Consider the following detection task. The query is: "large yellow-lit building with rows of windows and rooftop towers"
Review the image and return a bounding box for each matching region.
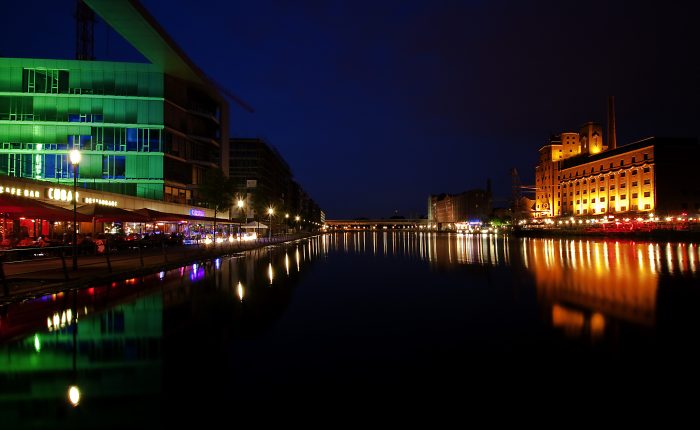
[534,129,700,218]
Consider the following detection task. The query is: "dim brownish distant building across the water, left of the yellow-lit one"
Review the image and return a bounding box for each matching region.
[428,182,492,227]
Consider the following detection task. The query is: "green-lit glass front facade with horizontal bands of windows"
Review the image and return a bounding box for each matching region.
[0,58,165,200]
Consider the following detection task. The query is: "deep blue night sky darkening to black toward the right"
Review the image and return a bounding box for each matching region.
[0,0,700,219]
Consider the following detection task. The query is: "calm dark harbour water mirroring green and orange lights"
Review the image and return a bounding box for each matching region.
[0,232,700,428]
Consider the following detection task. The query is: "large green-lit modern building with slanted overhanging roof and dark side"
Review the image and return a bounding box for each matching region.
[0,0,228,204]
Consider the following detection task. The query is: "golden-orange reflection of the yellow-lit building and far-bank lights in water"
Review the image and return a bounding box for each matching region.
[327,231,700,340]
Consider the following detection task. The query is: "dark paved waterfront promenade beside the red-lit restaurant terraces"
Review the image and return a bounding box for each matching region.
[0,232,318,303]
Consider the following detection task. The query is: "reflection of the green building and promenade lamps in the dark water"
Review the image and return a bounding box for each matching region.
[0,238,325,428]
